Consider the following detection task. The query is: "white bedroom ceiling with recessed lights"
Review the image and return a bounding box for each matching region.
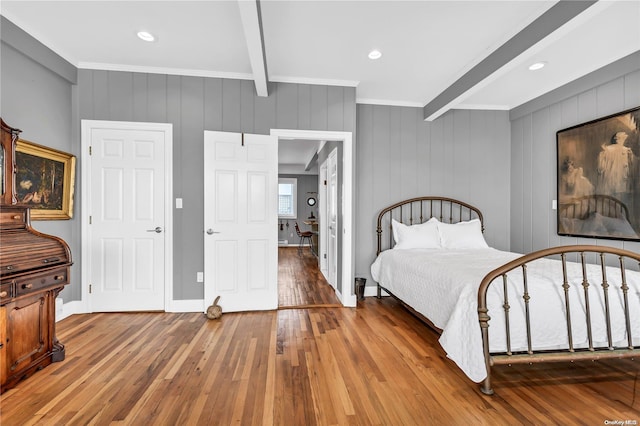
[0,0,640,168]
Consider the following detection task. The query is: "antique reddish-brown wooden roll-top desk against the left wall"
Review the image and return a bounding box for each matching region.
[0,119,71,392]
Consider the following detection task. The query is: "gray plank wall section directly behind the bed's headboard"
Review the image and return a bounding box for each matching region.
[355,105,511,285]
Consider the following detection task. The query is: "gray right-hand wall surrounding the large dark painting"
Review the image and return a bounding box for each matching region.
[511,52,640,253]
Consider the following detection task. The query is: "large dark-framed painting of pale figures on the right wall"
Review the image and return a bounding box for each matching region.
[556,107,640,241]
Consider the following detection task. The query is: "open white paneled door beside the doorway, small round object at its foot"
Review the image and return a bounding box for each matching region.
[204,131,278,312]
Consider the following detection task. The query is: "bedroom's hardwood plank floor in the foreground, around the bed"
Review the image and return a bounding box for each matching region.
[0,298,640,426]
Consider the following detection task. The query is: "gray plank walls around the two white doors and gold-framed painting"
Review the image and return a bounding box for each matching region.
[0,17,357,302]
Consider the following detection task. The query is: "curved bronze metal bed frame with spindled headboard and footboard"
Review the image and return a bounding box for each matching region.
[376,197,640,395]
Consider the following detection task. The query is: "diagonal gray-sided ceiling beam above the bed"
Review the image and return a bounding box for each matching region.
[422,0,597,121]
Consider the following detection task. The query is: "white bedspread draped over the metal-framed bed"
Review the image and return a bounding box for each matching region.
[371,248,640,382]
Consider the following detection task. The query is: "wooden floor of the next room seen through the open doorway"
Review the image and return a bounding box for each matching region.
[278,247,342,309]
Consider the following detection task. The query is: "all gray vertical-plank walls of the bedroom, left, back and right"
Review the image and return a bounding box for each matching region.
[8,12,640,302]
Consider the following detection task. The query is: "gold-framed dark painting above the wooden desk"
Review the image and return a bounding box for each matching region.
[16,139,76,220]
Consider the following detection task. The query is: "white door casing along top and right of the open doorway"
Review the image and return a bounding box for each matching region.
[271,129,357,307]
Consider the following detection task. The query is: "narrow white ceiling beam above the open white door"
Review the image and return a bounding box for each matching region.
[238,0,269,96]
